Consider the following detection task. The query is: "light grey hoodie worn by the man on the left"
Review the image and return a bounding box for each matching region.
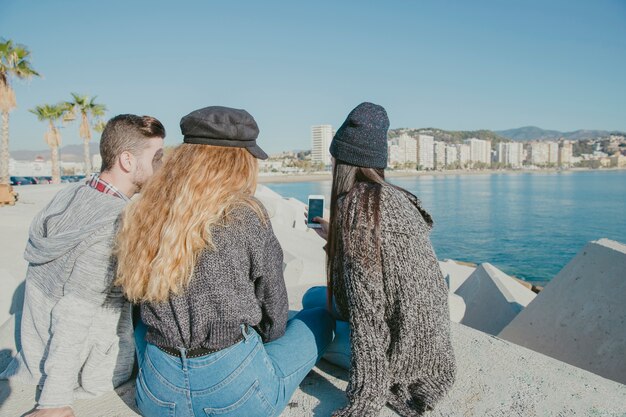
[0,184,134,408]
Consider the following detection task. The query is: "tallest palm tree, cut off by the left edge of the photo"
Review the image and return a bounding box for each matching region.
[0,39,39,184]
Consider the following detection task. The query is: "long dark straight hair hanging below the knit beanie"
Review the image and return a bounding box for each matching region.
[326,160,433,311]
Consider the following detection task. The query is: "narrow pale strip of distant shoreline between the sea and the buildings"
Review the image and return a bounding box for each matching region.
[258,168,626,184]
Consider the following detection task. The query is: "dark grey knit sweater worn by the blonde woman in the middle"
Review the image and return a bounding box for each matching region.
[141,206,289,350]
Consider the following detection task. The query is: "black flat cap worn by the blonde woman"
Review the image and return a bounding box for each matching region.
[180,106,267,159]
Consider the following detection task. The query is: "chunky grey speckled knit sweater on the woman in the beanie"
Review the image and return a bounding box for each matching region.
[333,184,456,417]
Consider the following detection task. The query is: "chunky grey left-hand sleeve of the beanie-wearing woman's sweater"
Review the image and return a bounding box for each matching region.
[333,231,390,417]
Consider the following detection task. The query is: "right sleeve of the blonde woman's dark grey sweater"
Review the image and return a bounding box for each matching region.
[254,226,289,343]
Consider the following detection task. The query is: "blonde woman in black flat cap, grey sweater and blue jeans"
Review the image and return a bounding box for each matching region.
[116,107,334,417]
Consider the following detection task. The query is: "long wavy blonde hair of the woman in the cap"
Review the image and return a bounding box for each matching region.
[114,143,267,303]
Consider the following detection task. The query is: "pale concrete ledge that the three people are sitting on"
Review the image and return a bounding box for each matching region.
[0,323,626,417]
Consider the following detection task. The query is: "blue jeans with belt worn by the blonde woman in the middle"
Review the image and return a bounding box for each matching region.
[135,308,335,417]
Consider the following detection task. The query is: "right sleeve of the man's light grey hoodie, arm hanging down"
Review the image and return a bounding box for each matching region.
[38,231,115,408]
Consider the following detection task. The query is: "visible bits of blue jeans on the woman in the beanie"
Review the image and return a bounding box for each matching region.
[302,286,351,369]
